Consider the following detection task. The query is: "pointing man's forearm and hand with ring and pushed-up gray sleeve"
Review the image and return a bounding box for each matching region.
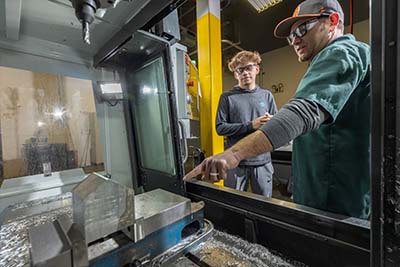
[183,99,330,181]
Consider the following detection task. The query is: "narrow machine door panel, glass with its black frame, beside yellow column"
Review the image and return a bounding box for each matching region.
[126,46,183,194]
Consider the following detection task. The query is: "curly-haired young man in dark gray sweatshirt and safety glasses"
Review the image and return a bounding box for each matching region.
[216,51,277,197]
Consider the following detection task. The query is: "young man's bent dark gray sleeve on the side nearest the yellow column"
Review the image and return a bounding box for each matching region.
[215,95,254,136]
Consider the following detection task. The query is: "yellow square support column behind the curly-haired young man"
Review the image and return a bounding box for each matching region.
[197,0,224,157]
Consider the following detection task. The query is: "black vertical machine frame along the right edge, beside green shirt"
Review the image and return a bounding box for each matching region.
[370,0,400,267]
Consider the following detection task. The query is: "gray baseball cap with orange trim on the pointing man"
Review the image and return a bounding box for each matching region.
[274,0,344,38]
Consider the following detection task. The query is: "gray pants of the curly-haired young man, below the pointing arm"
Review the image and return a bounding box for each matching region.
[224,163,274,197]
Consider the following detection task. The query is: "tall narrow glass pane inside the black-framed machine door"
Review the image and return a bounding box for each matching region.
[130,58,175,175]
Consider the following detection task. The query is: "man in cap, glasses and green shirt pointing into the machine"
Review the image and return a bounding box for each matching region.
[184,0,371,219]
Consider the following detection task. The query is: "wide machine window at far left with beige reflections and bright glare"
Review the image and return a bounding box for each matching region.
[0,67,103,182]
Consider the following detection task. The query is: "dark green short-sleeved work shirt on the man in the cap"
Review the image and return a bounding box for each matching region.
[293,34,371,218]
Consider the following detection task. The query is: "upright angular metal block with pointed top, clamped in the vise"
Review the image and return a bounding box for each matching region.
[72,174,135,244]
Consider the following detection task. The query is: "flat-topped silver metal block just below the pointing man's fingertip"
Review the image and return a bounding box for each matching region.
[133,189,192,242]
